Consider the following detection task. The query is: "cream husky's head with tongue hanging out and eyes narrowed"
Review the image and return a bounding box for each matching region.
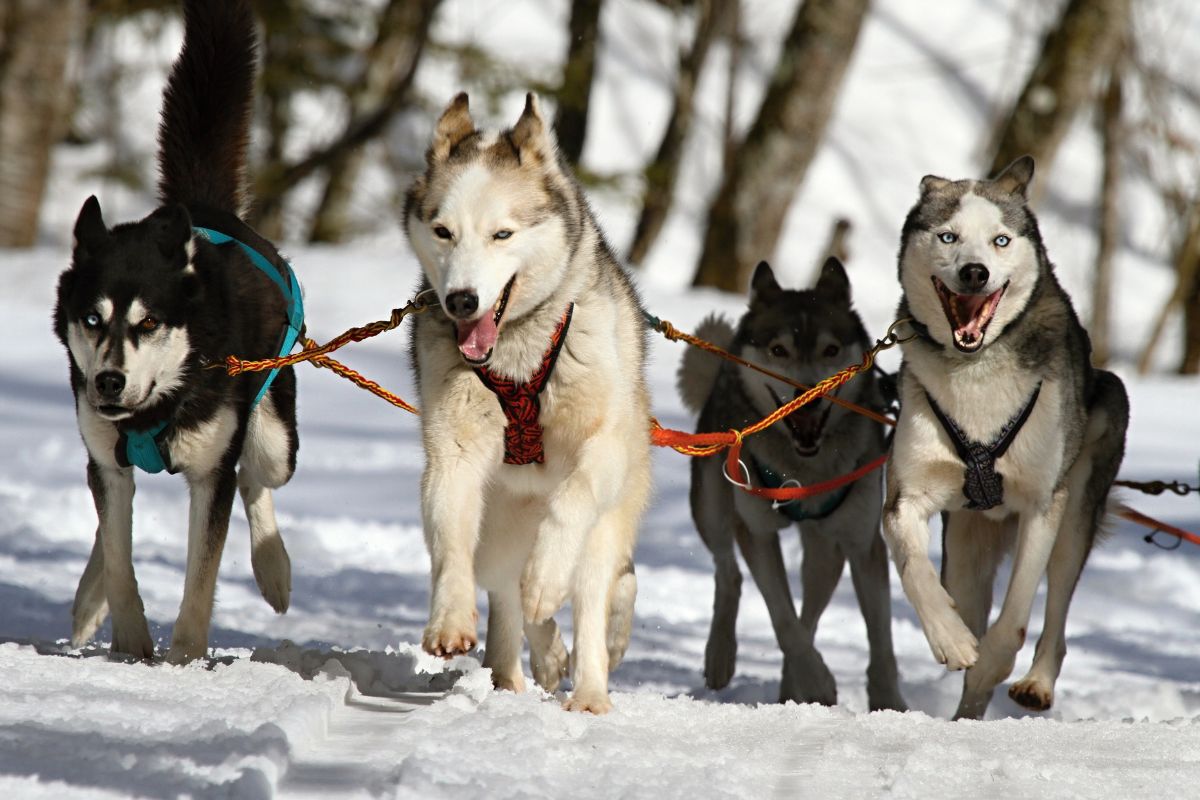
[406,95,578,366]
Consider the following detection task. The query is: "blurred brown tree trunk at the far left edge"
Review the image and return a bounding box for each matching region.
[0,0,88,247]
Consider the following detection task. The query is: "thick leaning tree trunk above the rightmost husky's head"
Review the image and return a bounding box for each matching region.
[988,0,1129,175]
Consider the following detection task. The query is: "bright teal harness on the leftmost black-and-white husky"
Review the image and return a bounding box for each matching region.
[116,227,304,475]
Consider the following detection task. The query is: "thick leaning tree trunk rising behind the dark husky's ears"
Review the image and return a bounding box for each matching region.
[694,0,869,291]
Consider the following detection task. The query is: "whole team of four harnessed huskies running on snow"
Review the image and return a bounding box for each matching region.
[54,0,1129,717]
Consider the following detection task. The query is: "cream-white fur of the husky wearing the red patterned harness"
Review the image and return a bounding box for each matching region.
[404,95,650,712]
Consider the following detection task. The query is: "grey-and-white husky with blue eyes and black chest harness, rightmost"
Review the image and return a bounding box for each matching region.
[883,156,1129,718]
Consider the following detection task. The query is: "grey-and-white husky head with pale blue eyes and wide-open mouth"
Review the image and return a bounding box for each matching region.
[900,160,1039,354]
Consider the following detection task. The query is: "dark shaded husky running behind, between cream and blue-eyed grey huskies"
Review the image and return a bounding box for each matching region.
[679,258,905,710]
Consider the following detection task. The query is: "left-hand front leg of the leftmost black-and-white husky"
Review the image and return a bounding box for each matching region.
[84,461,154,658]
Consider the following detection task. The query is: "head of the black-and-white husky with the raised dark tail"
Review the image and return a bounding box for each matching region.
[58,198,196,421]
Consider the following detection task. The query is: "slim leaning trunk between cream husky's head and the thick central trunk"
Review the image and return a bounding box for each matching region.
[629,0,720,264]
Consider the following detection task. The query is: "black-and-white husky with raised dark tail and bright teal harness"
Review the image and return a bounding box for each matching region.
[54,0,300,663]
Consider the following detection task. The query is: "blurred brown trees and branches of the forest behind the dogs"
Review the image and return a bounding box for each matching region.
[0,0,1200,373]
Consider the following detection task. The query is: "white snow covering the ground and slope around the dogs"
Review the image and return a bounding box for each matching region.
[0,0,1200,798]
